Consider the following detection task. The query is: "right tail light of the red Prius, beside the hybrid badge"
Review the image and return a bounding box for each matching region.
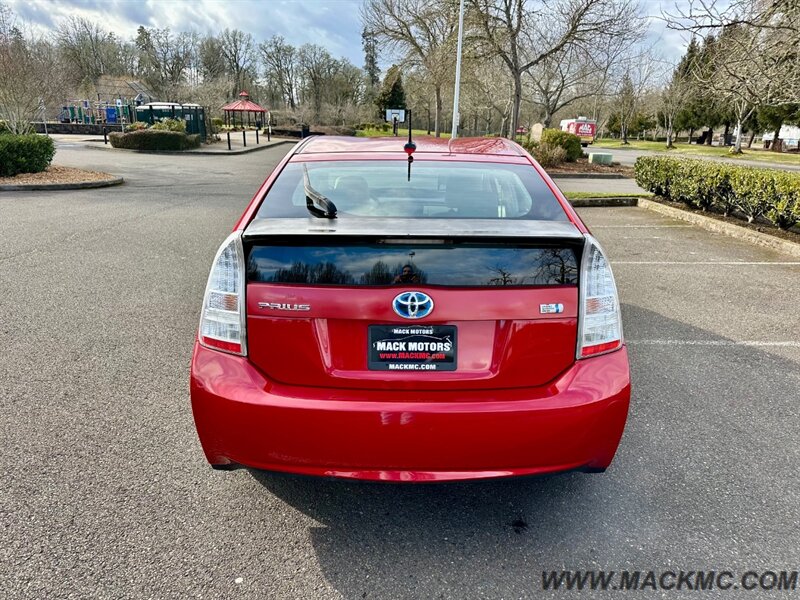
[576,236,622,358]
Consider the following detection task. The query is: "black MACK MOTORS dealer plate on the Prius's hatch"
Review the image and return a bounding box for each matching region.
[368,325,456,371]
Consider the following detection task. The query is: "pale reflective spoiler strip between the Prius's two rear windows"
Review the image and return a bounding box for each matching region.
[243,217,584,241]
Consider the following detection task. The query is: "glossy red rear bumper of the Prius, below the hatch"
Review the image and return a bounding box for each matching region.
[191,344,630,481]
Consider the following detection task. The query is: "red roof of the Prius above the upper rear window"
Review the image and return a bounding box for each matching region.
[295,135,525,156]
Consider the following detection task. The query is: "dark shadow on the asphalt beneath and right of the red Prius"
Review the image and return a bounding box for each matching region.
[251,305,800,598]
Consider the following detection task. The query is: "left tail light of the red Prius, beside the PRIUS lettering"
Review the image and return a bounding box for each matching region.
[198,231,247,356]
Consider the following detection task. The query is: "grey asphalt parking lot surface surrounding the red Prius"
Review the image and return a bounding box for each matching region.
[0,145,800,599]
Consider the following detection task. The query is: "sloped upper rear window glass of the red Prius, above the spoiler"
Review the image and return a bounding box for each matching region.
[257,160,567,221]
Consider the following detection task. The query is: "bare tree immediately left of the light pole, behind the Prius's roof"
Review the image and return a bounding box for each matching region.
[361,0,458,137]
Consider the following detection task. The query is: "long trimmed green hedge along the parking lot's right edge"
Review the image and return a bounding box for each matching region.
[633,156,800,229]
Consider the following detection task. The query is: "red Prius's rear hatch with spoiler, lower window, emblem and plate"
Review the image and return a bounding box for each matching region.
[244,219,584,390]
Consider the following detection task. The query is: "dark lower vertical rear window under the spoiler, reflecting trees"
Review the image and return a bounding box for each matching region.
[247,243,578,287]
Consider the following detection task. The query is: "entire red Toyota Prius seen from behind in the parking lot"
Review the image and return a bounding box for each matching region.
[191,137,630,482]
